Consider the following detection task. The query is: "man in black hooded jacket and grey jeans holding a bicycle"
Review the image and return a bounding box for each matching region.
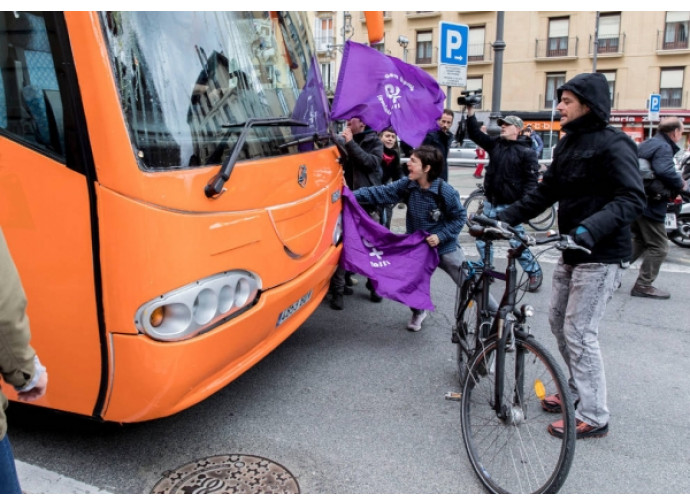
[498,73,645,439]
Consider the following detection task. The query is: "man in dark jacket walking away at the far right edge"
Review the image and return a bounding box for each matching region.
[630,117,684,299]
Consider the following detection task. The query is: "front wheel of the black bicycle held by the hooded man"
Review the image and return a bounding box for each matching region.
[461,336,575,493]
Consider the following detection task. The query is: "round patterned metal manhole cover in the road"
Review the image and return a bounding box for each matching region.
[151,455,299,494]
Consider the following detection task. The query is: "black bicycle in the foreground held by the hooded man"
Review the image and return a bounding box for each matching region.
[456,215,589,493]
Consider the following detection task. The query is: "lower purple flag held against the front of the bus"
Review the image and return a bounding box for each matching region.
[340,187,439,310]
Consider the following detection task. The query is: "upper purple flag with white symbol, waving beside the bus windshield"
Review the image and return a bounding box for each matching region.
[331,40,446,147]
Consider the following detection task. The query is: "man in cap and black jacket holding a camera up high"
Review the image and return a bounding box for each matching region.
[466,103,543,292]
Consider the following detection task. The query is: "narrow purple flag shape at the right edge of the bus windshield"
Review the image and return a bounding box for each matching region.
[292,56,330,151]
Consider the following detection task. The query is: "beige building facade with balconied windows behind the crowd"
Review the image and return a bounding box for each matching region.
[314,11,690,147]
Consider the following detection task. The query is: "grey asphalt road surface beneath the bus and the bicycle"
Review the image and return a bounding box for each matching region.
[8,164,690,494]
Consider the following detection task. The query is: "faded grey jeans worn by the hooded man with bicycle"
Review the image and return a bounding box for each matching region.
[549,258,620,427]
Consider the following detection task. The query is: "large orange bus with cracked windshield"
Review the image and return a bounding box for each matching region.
[0,11,383,422]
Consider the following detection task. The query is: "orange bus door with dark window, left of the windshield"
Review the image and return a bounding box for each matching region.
[0,12,102,415]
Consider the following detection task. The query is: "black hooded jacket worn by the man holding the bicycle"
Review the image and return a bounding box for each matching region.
[499,73,645,265]
